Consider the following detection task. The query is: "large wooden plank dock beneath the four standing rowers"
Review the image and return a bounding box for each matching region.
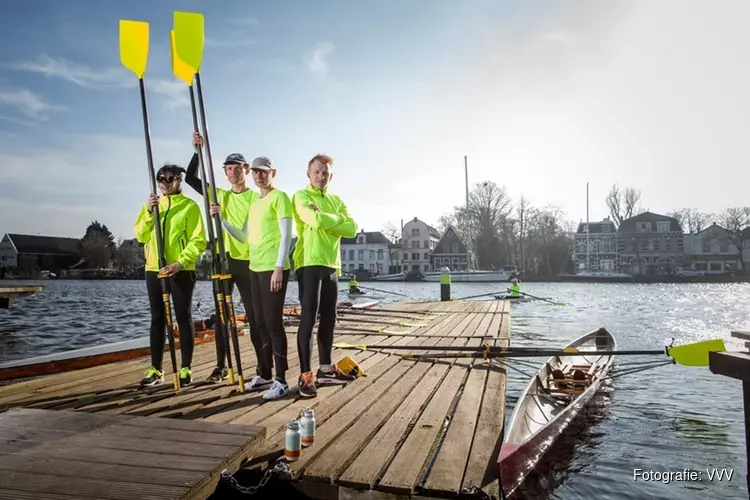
[0,300,510,500]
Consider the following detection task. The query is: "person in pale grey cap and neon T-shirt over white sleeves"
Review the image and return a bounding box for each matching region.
[217,156,292,400]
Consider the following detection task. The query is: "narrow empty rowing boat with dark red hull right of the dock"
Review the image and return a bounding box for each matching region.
[497,328,616,495]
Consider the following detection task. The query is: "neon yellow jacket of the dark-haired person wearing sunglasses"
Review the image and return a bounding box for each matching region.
[135,193,206,271]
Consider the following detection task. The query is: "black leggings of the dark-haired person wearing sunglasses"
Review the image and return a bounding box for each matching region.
[146,271,195,371]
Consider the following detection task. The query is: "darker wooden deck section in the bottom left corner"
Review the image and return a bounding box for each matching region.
[0,409,265,500]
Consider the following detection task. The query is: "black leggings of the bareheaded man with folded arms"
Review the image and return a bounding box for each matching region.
[297,266,339,373]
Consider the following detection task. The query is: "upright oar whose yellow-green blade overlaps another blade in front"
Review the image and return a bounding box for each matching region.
[174,11,245,392]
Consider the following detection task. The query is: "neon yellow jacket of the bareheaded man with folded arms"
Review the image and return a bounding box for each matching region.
[292,185,358,275]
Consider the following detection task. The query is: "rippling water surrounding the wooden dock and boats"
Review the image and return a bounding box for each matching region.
[0,281,750,500]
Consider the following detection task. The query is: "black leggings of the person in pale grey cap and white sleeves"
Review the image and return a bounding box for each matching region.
[250,271,289,381]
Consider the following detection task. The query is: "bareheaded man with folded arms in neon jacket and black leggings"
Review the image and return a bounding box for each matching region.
[292,154,357,398]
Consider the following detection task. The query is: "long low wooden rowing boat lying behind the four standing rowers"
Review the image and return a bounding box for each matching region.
[0,300,380,382]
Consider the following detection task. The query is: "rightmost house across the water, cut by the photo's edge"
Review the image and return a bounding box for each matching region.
[683,222,750,274]
